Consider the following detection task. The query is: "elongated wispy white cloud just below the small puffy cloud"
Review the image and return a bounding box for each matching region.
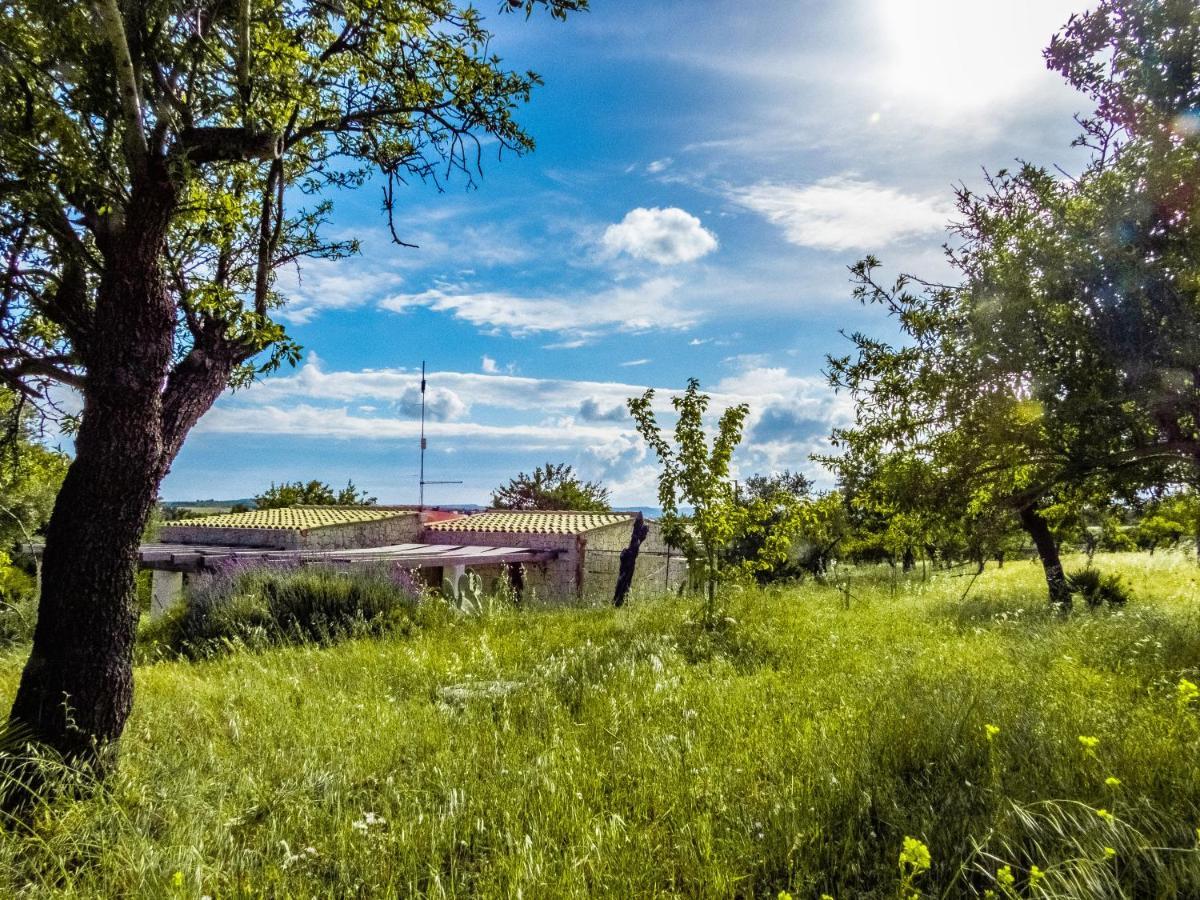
[379,277,697,337]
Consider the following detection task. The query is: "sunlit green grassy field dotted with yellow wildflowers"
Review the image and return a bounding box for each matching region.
[0,554,1200,900]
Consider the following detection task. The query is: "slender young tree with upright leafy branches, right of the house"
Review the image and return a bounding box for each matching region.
[629,378,748,624]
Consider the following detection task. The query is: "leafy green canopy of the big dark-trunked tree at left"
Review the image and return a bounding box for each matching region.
[0,0,587,400]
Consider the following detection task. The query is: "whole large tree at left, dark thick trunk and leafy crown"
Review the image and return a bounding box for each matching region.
[0,0,587,792]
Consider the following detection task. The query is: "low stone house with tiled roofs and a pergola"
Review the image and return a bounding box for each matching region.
[148,506,688,611]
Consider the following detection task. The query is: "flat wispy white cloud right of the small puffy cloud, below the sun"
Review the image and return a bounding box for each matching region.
[731,175,952,251]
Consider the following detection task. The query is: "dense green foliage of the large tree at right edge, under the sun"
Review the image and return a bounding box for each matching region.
[829,0,1200,607]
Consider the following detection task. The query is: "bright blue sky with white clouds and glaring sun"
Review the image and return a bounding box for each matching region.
[162,0,1085,505]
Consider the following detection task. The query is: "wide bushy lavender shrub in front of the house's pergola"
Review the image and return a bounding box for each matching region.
[143,566,420,658]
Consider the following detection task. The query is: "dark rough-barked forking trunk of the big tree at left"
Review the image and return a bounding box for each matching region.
[5,172,233,809]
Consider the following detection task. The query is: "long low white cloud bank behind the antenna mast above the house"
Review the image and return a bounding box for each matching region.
[198,355,852,503]
